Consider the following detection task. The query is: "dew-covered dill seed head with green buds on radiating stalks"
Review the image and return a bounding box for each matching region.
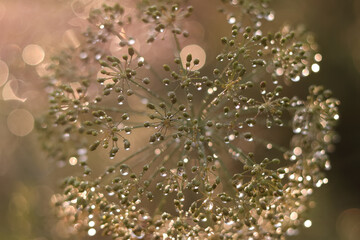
[40,0,339,239]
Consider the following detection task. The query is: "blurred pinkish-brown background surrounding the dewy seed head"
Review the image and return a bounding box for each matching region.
[0,0,360,240]
